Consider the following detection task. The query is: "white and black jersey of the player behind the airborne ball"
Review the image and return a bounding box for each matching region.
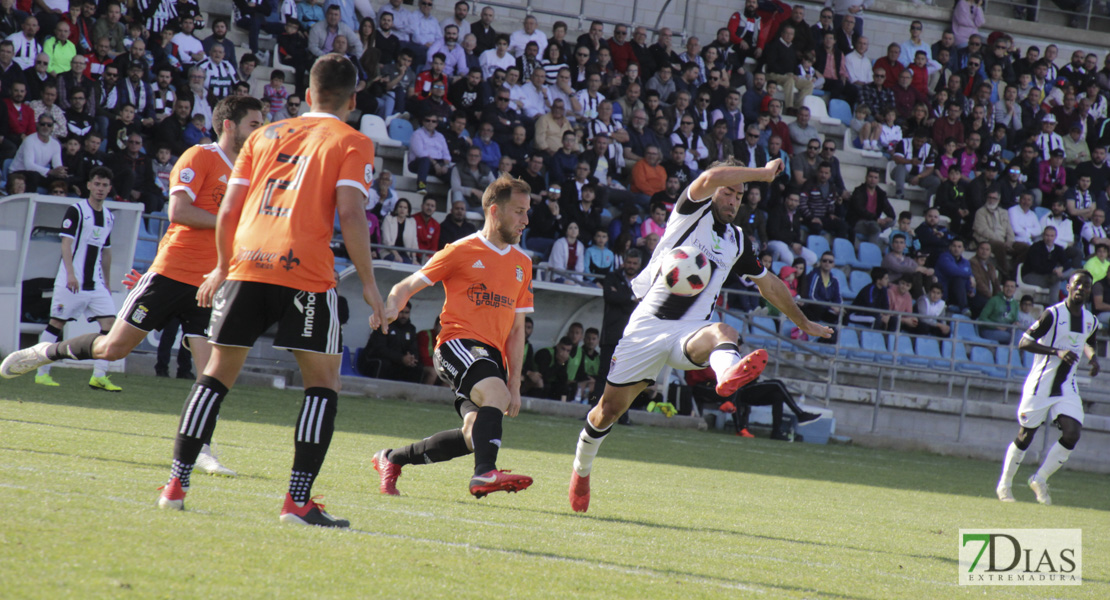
[630,187,767,323]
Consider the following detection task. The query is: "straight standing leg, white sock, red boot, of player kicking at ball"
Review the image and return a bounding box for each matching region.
[567,382,647,512]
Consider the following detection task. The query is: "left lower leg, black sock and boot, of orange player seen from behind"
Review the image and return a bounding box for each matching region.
[158,375,228,510]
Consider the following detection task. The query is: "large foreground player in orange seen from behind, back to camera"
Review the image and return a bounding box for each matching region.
[158,53,383,527]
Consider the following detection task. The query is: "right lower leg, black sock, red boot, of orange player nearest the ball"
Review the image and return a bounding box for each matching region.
[471,377,532,498]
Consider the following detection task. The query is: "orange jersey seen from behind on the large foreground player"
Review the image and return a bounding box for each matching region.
[228,112,374,293]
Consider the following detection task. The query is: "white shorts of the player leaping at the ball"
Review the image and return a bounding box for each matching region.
[605,318,713,387]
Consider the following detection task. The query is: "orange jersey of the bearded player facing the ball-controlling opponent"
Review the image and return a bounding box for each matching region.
[420,233,532,357]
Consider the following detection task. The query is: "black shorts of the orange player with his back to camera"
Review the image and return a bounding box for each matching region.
[209,279,343,354]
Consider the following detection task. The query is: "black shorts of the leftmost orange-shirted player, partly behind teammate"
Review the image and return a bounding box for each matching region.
[117,272,211,337]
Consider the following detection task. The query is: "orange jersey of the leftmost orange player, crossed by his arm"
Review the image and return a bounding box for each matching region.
[150,144,232,286]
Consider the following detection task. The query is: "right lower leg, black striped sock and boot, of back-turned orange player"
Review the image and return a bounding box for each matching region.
[280,387,351,527]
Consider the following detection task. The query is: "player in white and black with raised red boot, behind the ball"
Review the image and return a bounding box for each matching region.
[569,159,833,512]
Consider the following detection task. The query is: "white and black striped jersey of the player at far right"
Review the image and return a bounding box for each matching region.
[1022,302,1099,397]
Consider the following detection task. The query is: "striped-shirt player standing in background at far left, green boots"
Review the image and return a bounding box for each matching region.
[23,166,121,391]
